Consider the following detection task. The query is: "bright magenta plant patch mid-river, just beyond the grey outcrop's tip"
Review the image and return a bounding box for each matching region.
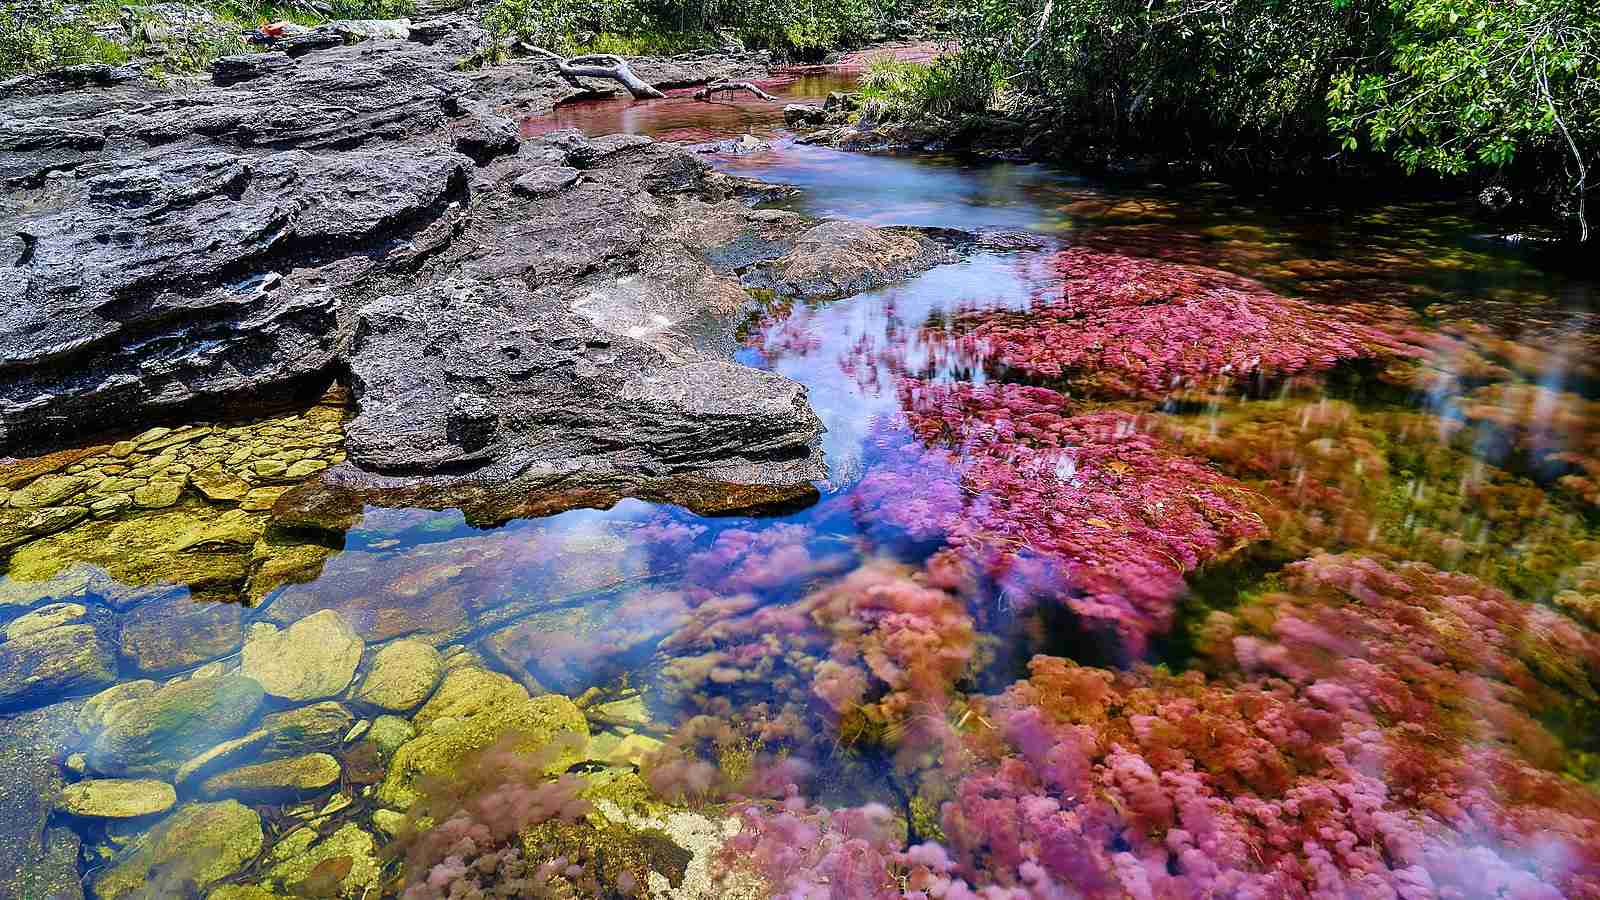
[848,380,1266,658]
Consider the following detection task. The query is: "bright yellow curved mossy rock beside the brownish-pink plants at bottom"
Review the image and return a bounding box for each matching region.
[378,682,589,810]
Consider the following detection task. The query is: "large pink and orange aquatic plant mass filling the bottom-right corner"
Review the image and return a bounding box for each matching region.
[725,556,1600,900]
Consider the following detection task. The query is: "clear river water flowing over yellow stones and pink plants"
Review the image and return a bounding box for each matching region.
[0,75,1600,897]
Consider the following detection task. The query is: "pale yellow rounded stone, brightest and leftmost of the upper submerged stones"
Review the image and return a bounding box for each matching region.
[242,610,365,700]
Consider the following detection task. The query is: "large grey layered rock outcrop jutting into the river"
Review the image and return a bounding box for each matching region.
[0,21,960,512]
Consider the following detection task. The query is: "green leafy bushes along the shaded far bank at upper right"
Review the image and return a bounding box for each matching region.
[869,0,1600,237]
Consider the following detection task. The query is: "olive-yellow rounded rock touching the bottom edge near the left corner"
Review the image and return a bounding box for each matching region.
[91,801,264,900]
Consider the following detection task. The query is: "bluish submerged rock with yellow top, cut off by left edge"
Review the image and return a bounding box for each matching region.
[0,625,117,708]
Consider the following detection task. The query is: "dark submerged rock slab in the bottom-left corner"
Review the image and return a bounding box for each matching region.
[0,701,83,900]
